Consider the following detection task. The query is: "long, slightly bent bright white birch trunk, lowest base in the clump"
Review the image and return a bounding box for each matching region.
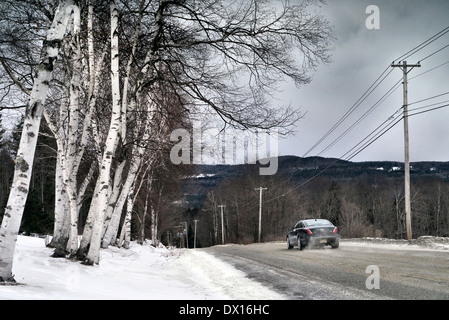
[84,0,121,265]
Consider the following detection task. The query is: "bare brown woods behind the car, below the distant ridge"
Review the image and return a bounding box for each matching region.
[173,162,449,247]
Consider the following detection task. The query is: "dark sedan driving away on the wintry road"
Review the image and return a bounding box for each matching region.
[287,219,340,250]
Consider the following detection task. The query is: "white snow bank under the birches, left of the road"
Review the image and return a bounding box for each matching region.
[0,236,283,300]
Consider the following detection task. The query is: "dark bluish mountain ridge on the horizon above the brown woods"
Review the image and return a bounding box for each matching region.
[183,156,449,208]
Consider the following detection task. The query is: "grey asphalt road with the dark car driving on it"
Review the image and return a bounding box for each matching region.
[203,241,449,300]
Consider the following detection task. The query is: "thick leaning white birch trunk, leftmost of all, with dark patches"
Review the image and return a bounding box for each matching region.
[0,0,74,282]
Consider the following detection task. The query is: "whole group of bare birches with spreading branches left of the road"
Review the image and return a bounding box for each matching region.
[0,0,332,282]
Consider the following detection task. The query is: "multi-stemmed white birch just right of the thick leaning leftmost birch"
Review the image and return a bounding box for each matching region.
[45,1,108,257]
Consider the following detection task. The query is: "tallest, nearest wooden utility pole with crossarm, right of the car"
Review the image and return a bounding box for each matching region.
[391,61,421,240]
